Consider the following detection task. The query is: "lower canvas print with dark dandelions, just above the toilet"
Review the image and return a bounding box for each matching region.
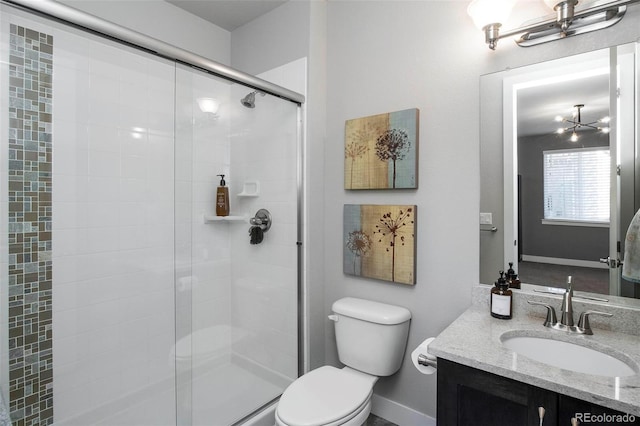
[343,204,416,285]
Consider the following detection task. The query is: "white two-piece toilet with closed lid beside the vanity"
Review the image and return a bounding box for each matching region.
[276,297,411,426]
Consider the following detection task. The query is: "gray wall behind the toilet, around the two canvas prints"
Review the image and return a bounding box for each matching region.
[324,1,480,421]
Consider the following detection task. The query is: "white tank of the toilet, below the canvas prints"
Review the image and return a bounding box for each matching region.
[332,297,411,376]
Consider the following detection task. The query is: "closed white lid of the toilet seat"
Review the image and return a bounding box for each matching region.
[278,366,376,426]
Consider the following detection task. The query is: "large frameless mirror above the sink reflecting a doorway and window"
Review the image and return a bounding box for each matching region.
[480,44,640,298]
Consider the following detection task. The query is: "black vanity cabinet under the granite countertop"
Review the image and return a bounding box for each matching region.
[437,358,640,426]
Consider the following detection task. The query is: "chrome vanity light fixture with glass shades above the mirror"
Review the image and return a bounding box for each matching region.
[467,0,640,50]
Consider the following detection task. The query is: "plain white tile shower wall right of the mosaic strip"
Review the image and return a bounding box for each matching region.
[53,30,175,425]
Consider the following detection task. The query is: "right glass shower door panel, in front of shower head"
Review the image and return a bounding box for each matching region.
[175,61,300,425]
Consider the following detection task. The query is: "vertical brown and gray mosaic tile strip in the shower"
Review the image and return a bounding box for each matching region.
[8,25,53,426]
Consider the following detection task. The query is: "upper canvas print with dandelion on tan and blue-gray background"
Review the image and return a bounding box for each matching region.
[344,108,419,189]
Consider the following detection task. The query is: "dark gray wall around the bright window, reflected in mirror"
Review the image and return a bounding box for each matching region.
[518,132,609,262]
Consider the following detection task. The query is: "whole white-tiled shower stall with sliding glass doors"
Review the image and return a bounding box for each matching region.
[0,1,306,426]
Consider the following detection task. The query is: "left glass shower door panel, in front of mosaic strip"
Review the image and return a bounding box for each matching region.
[0,4,176,425]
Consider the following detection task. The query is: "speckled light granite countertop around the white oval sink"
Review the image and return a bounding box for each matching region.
[429,287,640,416]
